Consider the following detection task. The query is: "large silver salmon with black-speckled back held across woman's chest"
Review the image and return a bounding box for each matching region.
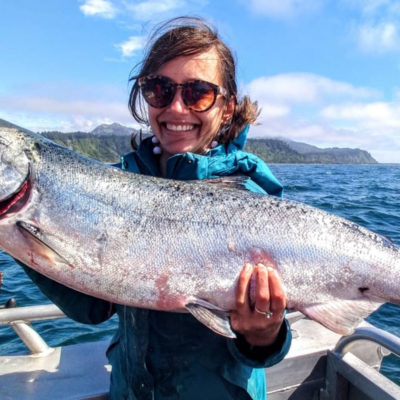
[0,119,400,336]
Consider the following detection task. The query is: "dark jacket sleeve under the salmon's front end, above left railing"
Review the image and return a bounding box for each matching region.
[19,260,115,324]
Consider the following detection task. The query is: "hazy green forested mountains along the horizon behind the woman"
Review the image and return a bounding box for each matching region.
[0,119,377,164]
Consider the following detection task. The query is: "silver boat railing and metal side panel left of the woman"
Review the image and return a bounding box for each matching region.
[0,302,111,400]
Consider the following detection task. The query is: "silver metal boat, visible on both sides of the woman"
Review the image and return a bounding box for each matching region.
[0,306,400,400]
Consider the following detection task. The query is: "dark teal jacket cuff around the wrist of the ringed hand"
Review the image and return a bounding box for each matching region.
[227,318,292,368]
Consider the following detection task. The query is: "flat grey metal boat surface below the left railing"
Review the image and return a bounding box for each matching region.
[0,341,111,400]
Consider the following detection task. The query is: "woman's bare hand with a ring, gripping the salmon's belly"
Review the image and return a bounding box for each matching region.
[231,264,286,346]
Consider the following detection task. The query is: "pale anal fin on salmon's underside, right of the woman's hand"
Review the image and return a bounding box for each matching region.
[300,299,383,335]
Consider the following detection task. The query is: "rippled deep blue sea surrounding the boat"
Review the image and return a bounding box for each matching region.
[0,164,400,384]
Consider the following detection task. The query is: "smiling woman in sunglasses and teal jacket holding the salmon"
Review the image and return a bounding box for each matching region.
[23,18,291,400]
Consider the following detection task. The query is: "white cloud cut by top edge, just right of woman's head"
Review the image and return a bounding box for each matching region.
[242,0,323,19]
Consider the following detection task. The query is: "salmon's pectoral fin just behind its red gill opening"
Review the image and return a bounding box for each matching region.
[16,221,71,266]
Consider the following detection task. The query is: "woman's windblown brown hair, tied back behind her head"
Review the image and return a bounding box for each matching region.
[129,17,259,143]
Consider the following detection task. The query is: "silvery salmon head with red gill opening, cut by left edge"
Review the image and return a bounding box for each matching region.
[0,127,31,219]
